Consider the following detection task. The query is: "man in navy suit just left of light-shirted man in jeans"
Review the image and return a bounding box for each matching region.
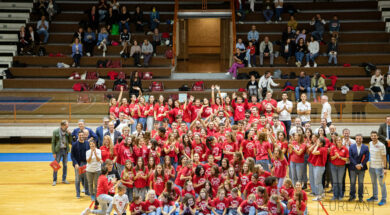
[348,134,370,202]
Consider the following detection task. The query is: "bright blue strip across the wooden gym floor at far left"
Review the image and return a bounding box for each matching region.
[0,153,71,162]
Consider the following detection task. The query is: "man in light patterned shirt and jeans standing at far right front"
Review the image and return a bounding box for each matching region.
[367,131,387,206]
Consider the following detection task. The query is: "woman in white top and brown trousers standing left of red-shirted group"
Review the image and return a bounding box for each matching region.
[86,141,102,201]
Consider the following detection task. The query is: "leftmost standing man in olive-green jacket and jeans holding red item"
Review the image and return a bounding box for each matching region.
[51,120,72,186]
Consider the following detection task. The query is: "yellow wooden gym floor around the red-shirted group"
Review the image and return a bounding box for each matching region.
[0,144,390,215]
